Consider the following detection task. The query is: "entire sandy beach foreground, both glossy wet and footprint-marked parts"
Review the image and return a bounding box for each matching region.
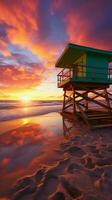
[0,113,112,200]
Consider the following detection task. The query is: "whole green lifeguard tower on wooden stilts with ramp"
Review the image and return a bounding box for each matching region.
[56,43,112,128]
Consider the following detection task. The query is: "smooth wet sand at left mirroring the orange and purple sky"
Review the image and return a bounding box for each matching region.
[0,113,63,197]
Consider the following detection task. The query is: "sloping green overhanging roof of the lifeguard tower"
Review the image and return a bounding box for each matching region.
[55,43,112,68]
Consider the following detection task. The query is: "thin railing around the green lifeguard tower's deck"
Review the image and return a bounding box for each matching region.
[57,65,112,86]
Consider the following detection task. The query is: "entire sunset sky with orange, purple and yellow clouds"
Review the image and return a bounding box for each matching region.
[0,0,112,100]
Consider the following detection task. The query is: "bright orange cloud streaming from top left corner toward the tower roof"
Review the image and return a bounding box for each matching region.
[0,0,57,62]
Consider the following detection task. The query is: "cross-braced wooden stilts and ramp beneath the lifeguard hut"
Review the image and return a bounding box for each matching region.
[63,86,112,127]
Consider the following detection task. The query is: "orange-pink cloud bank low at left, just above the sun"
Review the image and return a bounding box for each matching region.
[0,63,44,90]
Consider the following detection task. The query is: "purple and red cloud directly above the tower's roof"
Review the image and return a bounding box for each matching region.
[52,0,112,49]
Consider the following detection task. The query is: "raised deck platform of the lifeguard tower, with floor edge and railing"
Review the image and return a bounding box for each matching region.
[57,65,112,88]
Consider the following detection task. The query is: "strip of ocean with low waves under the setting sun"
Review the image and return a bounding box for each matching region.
[0,100,62,122]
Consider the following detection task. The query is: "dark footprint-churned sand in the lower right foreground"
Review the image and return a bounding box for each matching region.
[6,118,112,200]
